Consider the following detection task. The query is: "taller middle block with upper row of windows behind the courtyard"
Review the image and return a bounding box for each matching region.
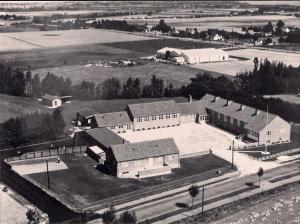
[127,100,180,131]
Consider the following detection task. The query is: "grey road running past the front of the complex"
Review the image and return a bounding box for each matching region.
[123,162,300,221]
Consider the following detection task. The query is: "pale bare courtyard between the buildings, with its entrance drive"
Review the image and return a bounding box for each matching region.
[119,123,278,175]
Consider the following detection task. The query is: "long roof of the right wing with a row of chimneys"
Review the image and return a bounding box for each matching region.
[201,94,277,132]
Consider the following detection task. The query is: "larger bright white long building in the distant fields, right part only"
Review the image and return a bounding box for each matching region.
[181,48,229,64]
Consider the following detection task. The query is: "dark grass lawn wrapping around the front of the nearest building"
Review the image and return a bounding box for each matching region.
[29,155,229,205]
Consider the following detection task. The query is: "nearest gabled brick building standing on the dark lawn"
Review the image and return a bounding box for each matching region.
[107,138,180,178]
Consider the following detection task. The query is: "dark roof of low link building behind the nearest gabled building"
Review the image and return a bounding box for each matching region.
[86,128,124,148]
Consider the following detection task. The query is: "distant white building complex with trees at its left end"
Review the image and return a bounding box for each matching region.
[157,47,229,64]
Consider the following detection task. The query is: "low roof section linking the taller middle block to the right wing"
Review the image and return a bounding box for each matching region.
[177,101,207,115]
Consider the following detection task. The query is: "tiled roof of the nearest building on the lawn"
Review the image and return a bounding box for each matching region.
[111,138,179,162]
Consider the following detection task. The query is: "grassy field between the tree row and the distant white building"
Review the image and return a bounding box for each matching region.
[33,62,222,88]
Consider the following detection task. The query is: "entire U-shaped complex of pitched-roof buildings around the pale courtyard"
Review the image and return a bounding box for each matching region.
[77,94,291,178]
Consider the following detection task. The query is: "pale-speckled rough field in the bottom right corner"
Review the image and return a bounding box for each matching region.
[211,186,300,224]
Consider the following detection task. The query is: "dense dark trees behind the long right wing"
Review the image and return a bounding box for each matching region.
[180,60,300,123]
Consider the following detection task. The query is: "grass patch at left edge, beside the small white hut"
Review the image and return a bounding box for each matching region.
[0,94,52,123]
